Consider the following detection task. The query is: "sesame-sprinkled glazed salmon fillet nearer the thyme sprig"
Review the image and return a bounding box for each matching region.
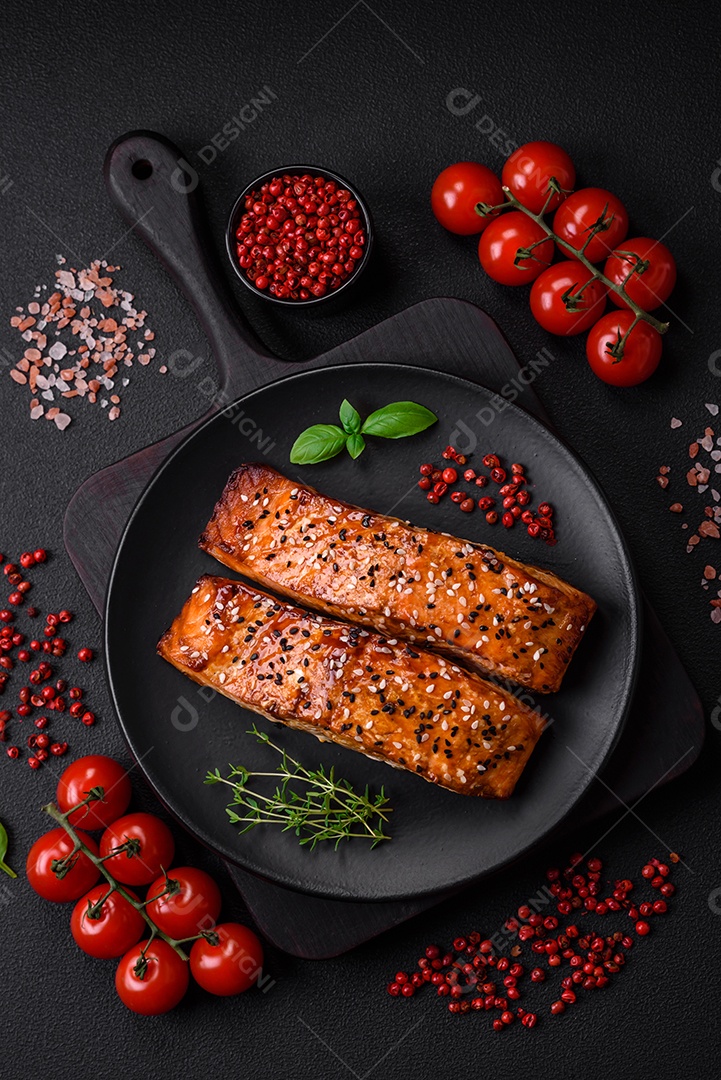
[158,575,543,798]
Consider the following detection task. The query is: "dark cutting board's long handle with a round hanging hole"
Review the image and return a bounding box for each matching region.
[104,131,271,382]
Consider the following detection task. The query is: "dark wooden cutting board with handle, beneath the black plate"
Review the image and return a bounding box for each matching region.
[65,132,704,958]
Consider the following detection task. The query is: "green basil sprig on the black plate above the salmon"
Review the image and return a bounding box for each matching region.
[290,399,438,465]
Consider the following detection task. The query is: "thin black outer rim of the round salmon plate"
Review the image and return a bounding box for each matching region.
[104,362,641,903]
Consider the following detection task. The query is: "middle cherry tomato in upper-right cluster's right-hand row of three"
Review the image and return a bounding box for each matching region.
[554,188,628,262]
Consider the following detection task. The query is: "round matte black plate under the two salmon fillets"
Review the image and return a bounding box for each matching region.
[106,364,639,901]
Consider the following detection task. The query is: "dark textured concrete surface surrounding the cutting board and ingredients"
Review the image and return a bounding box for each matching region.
[0,0,721,1080]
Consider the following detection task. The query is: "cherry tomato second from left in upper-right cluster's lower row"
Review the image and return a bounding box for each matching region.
[478,210,554,285]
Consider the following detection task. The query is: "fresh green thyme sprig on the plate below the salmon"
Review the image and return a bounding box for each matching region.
[205,725,392,851]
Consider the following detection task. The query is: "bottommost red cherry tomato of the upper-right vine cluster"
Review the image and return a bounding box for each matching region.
[586,311,662,387]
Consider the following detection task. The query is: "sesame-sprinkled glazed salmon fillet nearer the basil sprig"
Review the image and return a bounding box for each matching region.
[200,464,596,693]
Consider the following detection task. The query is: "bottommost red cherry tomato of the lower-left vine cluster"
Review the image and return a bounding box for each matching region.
[115,937,190,1016]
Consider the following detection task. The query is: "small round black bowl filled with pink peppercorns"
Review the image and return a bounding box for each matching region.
[226,165,372,308]
